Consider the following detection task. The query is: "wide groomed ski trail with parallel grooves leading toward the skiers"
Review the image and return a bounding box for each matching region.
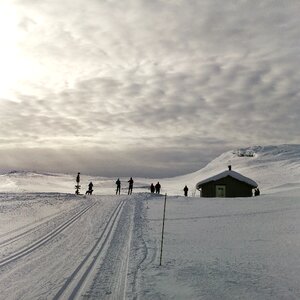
[0,194,152,300]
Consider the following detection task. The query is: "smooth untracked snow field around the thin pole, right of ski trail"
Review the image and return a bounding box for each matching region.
[139,192,300,300]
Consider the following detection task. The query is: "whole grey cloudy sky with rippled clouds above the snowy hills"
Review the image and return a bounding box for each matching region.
[0,0,300,177]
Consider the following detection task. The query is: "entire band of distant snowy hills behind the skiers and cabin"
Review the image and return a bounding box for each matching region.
[0,145,300,195]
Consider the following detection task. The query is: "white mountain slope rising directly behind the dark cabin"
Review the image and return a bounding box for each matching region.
[163,145,300,195]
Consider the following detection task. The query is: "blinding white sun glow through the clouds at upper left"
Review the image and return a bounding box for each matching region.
[0,1,78,102]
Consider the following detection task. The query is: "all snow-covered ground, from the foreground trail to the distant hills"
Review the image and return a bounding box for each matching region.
[0,145,300,299]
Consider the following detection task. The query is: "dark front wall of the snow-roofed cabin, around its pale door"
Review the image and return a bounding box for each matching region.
[201,176,253,198]
